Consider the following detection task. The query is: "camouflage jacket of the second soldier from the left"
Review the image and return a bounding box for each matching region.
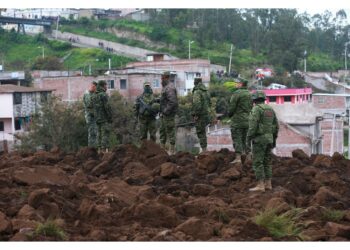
[92,87,112,123]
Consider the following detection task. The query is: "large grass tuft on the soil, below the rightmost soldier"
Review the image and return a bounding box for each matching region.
[254,209,301,238]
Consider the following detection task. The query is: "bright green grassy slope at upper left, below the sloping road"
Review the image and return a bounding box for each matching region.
[0,29,135,74]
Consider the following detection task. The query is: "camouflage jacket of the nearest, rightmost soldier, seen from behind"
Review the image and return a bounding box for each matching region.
[247,104,279,144]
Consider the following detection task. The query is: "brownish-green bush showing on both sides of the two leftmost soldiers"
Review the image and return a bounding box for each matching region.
[16,92,138,152]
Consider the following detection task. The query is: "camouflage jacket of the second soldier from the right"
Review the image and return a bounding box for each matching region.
[229,88,253,128]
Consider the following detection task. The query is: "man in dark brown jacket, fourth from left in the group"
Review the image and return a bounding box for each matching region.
[159,71,178,154]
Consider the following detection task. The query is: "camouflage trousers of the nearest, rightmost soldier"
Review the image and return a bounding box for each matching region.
[253,142,272,181]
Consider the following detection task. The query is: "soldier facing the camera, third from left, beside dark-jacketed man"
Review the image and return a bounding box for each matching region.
[135,82,159,142]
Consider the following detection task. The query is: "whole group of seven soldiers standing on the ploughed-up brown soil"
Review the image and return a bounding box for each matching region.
[83,72,279,192]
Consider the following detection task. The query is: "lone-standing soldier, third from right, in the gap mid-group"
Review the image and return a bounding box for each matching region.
[192,77,211,152]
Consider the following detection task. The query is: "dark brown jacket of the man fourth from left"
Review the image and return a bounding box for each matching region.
[160,83,178,116]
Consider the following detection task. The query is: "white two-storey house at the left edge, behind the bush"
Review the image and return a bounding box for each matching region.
[0,84,52,151]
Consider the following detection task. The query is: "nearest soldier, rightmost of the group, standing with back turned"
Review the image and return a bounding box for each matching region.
[247,91,279,192]
